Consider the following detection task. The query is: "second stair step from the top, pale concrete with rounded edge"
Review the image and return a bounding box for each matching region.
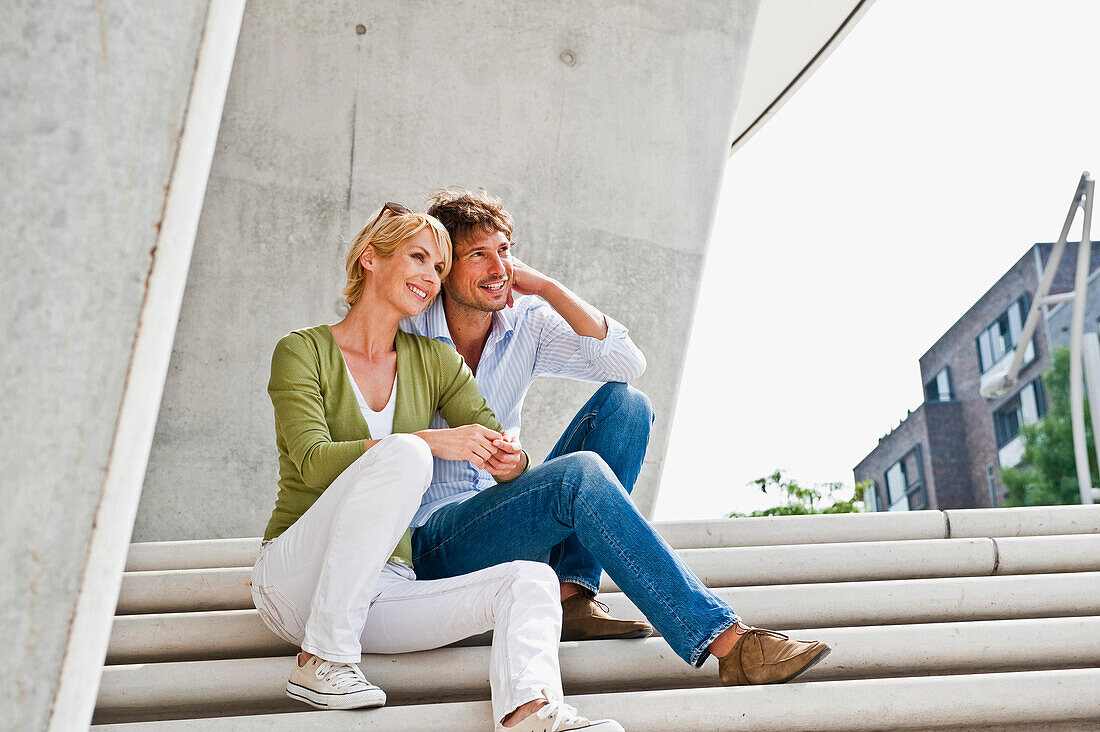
[117,534,1100,615]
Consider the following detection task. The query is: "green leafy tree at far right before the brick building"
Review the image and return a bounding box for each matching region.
[1001,348,1097,506]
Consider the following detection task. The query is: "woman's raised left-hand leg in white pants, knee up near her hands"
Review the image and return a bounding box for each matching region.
[252,435,431,663]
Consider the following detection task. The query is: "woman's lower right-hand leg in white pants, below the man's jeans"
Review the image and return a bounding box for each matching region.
[362,561,562,722]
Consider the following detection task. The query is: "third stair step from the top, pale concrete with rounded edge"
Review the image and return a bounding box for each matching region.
[107,572,1100,665]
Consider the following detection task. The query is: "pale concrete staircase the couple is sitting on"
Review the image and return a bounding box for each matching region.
[95,506,1100,732]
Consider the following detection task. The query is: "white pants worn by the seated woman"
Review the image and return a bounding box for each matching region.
[252,435,562,721]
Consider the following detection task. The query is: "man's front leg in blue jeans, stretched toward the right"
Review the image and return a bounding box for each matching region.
[413,451,738,665]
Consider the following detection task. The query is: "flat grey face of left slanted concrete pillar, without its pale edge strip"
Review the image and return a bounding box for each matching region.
[0,0,207,730]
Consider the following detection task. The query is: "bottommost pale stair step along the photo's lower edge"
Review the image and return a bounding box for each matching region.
[96,668,1100,732]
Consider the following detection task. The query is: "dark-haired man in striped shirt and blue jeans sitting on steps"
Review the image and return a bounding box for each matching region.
[403,189,828,684]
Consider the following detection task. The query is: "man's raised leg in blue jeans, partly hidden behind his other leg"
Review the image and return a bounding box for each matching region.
[547,382,653,598]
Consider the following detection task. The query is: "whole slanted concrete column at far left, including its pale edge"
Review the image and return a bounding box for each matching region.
[0,0,241,730]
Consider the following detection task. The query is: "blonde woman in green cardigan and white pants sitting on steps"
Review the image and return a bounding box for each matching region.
[252,204,622,732]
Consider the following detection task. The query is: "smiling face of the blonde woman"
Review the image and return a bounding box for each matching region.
[364,227,443,317]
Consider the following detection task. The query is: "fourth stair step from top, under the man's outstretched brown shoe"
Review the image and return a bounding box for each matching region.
[96,616,1100,723]
